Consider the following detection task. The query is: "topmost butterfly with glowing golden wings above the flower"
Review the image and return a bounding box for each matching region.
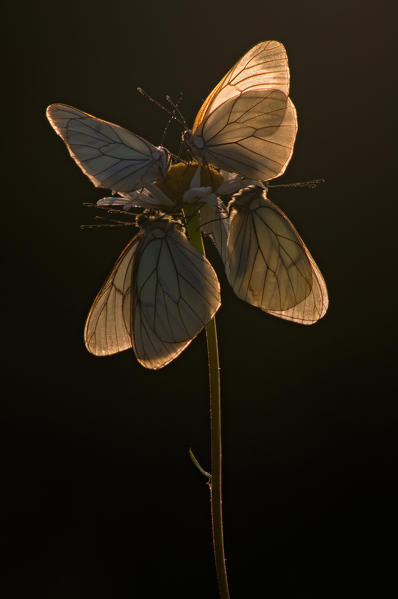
[184,41,297,181]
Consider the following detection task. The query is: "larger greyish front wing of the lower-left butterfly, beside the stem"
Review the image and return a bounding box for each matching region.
[133,220,221,369]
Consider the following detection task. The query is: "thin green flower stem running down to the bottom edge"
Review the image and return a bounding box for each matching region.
[184,210,229,599]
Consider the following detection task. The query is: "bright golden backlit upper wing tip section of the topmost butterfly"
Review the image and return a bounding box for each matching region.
[192,41,290,134]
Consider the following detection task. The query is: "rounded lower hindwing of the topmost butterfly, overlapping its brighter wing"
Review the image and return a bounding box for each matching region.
[186,89,297,181]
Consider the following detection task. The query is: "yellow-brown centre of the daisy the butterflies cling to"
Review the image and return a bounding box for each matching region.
[156,162,224,206]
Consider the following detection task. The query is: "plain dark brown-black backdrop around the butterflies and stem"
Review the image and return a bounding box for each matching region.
[1,0,397,599]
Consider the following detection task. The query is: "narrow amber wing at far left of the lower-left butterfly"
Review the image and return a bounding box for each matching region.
[84,234,141,356]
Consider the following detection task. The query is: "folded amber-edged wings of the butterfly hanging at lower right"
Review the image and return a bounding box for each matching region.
[227,188,328,324]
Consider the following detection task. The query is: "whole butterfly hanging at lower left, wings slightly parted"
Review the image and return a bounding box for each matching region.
[84,218,221,369]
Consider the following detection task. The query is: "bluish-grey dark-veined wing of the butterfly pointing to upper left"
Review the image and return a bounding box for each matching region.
[47,104,170,193]
